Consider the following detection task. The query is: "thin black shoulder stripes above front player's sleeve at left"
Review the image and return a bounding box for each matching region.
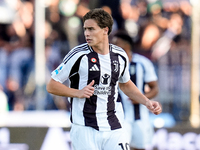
[63,44,91,64]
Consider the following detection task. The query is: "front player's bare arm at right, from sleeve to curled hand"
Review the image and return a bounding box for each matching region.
[119,80,162,115]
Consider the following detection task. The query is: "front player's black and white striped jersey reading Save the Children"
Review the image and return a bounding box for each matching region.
[52,43,130,131]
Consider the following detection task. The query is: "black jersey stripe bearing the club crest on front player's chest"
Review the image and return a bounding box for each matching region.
[107,52,121,130]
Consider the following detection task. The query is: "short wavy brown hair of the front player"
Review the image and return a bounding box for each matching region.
[83,8,113,35]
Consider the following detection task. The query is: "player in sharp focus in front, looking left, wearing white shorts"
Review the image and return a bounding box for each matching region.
[47,8,162,150]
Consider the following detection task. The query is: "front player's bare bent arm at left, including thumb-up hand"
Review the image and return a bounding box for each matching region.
[46,78,94,98]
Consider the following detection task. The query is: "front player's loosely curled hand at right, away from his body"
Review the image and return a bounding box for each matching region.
[146,100,162,115]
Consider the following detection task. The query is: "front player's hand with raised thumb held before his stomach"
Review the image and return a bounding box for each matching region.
[78,80,94,98]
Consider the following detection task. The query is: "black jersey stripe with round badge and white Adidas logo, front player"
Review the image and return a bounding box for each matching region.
[83,52,101,130]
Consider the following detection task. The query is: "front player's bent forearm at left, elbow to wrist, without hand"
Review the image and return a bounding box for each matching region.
[46,79,78,97]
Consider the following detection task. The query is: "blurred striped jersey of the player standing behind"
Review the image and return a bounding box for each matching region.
[120,53,157,123]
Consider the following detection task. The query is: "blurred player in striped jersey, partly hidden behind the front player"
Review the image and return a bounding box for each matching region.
[112,31,158,150]
